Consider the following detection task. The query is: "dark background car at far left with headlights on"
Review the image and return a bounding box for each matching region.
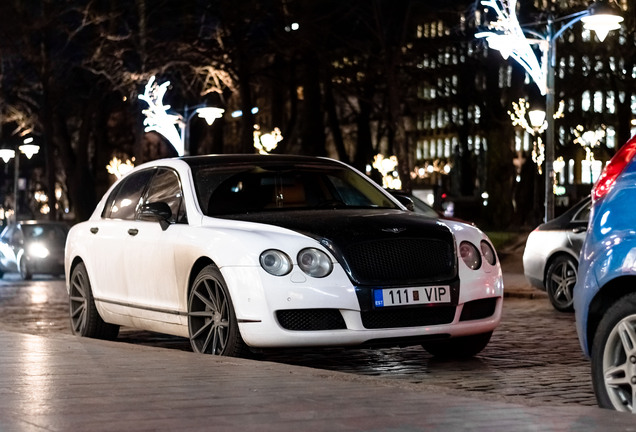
[0,220,69,280]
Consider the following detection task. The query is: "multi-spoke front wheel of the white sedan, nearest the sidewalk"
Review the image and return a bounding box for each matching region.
[188,264,249,357]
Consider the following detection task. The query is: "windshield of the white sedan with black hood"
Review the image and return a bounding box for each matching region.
[193,164,398,216]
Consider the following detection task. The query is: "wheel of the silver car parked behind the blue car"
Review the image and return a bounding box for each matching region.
[545,255,578,312]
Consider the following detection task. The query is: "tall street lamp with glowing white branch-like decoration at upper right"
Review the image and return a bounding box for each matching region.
[475,0,623,222]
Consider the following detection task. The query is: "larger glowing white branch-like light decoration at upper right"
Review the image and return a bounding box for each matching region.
[475,0,548,95]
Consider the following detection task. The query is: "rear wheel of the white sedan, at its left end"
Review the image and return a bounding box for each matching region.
[69,263,119,339]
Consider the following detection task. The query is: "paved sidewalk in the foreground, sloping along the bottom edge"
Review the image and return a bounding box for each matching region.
[0,330,634,432]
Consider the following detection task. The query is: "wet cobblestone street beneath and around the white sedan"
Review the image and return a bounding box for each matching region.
[0,274,596,406]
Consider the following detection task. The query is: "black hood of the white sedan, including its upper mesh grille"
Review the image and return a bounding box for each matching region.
[223,209,457,285]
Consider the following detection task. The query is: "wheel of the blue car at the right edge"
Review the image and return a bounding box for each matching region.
[592,293,636,413]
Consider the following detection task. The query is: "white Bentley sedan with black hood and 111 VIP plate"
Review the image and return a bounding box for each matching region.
[65,155,503,356]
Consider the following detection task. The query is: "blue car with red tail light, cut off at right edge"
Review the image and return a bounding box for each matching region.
[574,136,636,413]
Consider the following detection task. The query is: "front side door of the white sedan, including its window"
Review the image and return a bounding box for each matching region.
[125,167,188,323]
